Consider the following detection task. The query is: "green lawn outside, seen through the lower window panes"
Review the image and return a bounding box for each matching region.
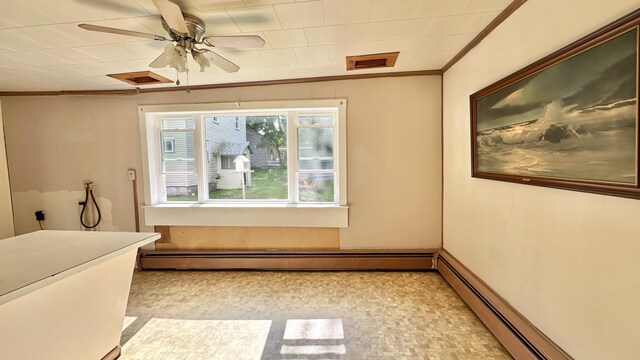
[167,169,333,202]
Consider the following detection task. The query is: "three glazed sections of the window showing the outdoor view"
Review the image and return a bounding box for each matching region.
[142,100,340,203]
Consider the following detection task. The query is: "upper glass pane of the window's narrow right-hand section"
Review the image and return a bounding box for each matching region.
[298,128,333,170]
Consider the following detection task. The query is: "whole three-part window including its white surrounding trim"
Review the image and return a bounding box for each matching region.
[140,100,347,226]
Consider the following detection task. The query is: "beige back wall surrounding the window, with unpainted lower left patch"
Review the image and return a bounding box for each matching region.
[2,76,441,248]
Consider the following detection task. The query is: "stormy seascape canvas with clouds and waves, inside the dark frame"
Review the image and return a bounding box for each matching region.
[475,27,638,185]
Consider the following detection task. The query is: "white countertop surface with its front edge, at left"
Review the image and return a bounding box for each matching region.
[0,230,160,305]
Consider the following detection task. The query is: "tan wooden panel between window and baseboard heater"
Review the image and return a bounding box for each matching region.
[156,226,340,250]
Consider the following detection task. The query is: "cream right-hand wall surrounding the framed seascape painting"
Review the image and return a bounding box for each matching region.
[443,0,640,359]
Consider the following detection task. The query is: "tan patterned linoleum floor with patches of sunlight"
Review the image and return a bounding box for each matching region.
[120,271,511,360]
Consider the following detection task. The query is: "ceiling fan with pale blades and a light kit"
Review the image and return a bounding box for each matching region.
[78,0,265,73]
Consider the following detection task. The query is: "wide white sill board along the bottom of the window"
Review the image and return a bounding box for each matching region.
[144,203,349,228]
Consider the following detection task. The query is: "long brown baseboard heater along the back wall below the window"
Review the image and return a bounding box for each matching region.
[140,249,437,270]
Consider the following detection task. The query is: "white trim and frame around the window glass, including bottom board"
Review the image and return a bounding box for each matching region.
[138,99,349,228]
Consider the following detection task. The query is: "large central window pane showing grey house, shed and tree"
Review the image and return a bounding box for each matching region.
[204,115,288,200]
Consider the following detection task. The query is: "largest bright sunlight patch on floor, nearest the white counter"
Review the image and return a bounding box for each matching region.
[120,318,271,360]
